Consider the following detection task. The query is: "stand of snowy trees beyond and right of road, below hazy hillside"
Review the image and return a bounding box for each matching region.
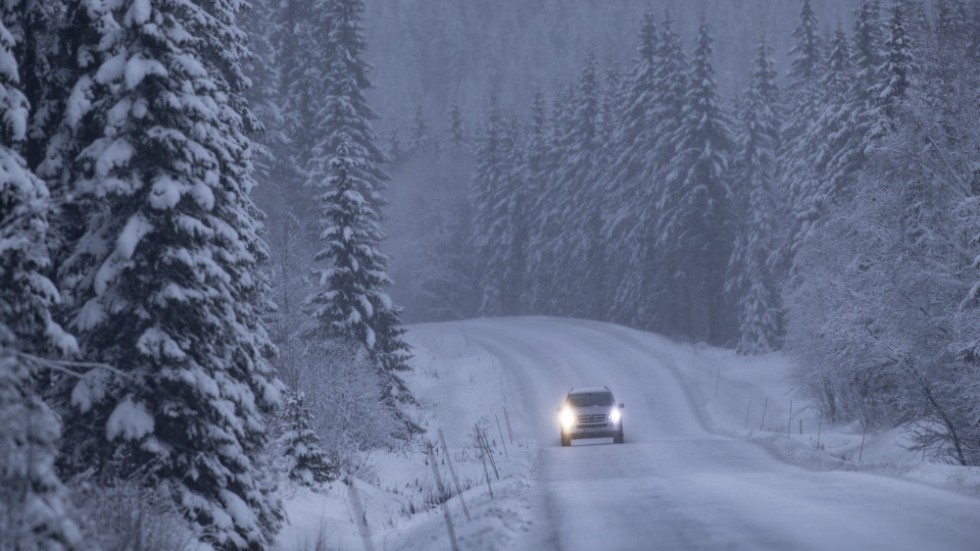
[376,0,980,464]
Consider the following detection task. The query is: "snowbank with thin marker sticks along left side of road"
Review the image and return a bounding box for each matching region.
[277,326,537,551]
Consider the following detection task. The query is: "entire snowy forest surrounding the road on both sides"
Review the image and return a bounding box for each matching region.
[0,0,980,550]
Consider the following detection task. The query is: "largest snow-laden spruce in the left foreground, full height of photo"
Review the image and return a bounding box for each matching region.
[52,0,282,549]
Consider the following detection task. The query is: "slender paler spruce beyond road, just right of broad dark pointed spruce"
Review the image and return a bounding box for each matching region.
[725,38,780,354]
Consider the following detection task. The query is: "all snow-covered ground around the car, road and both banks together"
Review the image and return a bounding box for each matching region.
[278,318,980,550]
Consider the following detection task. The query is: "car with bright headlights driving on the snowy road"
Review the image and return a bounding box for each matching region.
[558,386,626,446]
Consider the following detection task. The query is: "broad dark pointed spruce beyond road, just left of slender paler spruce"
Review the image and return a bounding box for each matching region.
[658,17,732,343]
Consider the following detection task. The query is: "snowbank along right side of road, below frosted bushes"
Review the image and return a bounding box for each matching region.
[671,344,980,495]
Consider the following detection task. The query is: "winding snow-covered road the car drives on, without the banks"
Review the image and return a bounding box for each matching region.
[440,318,980,551]
